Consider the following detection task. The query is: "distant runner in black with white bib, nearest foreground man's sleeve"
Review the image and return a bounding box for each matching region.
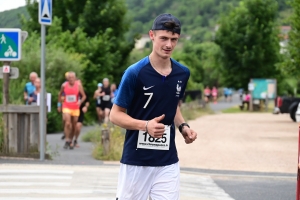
[100,78,112,124]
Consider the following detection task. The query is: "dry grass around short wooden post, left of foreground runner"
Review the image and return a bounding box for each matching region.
[82,126,125,161]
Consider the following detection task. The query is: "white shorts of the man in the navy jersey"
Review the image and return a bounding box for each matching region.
[117,163,180,200]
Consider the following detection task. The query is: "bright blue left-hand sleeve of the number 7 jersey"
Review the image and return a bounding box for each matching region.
[114,67,137,109]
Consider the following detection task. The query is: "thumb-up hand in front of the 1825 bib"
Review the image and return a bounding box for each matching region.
[147,115,165,138]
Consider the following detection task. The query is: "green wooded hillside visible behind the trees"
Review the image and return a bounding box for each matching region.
[0,0,291,41]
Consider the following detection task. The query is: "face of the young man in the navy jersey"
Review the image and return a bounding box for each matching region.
[149,30,179,59]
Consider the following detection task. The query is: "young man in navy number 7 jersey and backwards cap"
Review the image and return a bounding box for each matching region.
[110,14,197,200]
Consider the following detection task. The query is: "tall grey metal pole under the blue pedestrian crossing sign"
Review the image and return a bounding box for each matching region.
[40,25,46,160]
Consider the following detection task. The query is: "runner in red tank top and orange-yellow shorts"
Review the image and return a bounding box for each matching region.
[58,72,86,149]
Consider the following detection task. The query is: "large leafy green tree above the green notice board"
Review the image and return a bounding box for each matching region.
[216,0,280,89]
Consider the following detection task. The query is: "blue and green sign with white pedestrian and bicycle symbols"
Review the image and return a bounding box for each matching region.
[0,29,22,61]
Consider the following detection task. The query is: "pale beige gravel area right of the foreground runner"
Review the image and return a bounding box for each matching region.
[176,113,298,173]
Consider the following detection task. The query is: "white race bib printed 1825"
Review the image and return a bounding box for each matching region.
[137,125,171,150]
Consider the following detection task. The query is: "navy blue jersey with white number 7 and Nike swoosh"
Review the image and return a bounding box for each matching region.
[115,57,190,166]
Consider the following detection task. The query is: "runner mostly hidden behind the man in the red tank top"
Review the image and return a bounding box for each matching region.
[71,79,90,147]
